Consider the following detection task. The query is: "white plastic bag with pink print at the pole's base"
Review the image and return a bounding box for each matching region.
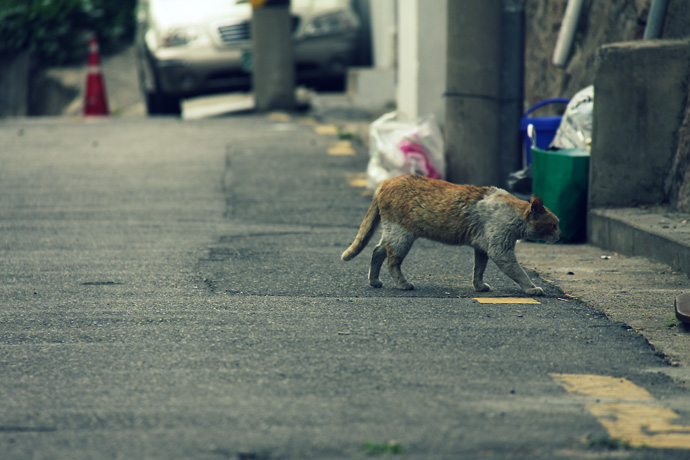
[367,112,446,190]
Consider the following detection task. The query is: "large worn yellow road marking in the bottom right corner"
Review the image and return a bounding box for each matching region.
[549,374,690,449]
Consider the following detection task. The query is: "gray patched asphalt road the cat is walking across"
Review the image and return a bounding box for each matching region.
[0,115,690,460]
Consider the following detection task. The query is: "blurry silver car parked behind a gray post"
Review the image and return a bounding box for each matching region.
[137,0,359,114]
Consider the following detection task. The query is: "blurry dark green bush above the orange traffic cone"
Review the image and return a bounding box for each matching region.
[0,0,136,66]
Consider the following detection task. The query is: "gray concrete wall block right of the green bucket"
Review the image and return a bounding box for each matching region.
[589,41,690,208]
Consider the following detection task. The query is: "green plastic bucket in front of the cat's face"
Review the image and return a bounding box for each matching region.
[532,146,589,243]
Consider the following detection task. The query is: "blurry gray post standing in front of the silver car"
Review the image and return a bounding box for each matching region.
[252,0,295,111]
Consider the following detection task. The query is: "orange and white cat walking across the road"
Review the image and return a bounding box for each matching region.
[341,175,561,295]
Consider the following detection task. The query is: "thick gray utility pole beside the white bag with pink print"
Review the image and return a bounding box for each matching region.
[445,0,500,185]
